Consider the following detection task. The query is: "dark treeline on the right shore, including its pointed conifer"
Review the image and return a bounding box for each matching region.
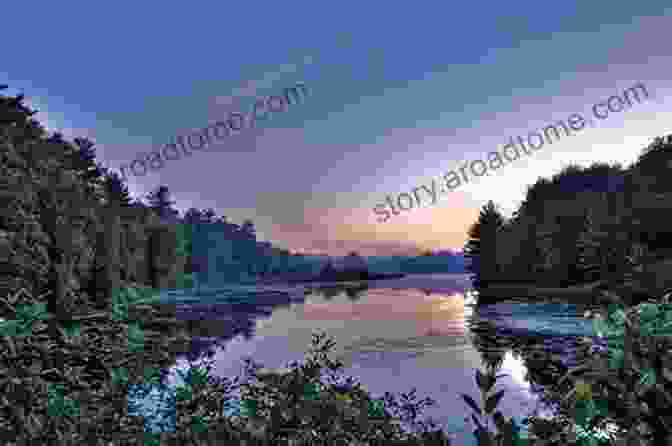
[465,135,672,287]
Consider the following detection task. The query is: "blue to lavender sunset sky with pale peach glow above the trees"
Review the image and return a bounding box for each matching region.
[5,0,672,255]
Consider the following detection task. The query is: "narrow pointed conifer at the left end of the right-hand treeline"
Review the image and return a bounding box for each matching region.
[464,201,504,288]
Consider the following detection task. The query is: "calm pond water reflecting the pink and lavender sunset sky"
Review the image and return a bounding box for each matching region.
[134,274,592,444]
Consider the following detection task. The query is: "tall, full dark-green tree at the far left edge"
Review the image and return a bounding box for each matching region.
[0,84,98,320]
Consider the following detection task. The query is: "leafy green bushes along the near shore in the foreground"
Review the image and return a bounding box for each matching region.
[7,280,672,446]
